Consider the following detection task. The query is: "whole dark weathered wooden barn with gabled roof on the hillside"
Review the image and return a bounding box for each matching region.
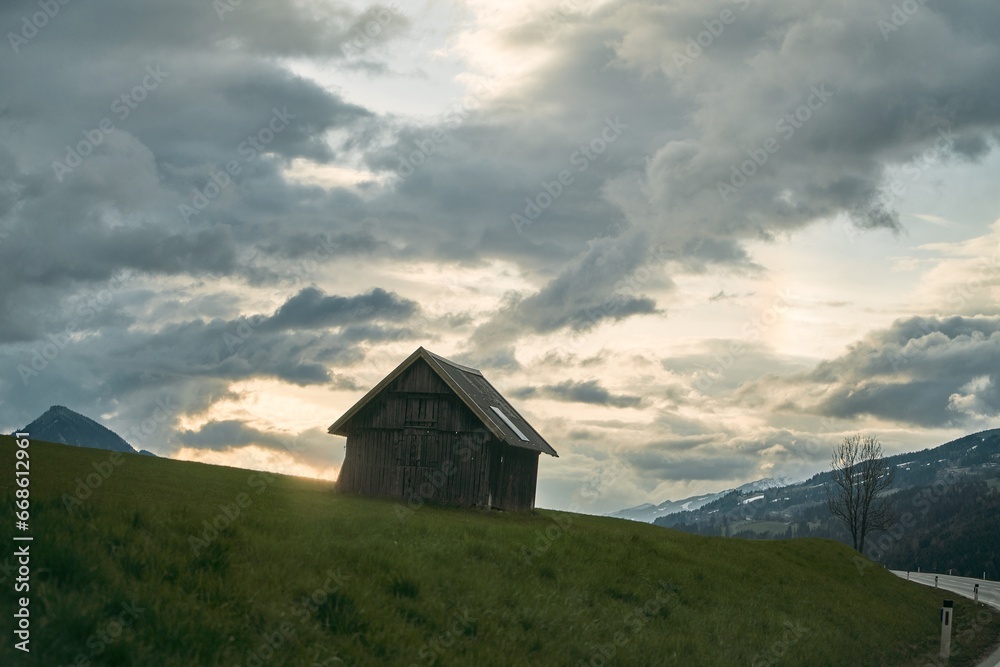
[329,347,559,511]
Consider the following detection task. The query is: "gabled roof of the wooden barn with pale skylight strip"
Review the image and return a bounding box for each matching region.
[328,347,559,456]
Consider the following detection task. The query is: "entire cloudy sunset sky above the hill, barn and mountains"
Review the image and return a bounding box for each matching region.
[0,0,1000,512]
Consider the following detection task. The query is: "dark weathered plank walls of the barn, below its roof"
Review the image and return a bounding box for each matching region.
[338,361,538,510]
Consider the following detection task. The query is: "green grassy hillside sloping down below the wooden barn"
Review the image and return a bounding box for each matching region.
[0,438,1000,667]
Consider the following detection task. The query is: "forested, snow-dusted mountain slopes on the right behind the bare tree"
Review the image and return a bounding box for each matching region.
[648,429,1000,579]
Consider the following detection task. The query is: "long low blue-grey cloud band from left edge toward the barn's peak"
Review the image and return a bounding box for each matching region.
[0,289,421,444]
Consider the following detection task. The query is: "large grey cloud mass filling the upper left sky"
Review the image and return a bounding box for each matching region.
[0,0,386,350]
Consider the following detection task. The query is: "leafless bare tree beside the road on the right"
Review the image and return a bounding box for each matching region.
[827,435,896,553]
